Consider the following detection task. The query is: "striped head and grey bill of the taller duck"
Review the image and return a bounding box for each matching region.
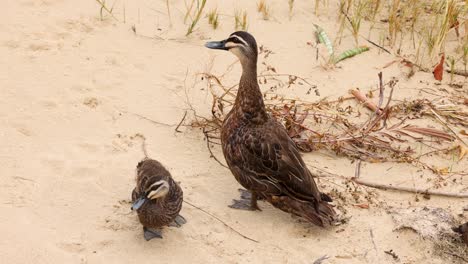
[205,31,258,65]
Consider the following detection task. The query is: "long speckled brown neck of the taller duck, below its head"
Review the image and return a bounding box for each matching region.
[234,60,267,123]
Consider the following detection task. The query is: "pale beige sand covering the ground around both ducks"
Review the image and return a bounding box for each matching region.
[0,0,468,263]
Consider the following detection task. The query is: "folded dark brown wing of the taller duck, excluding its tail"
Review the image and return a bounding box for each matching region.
[240,121,321,202]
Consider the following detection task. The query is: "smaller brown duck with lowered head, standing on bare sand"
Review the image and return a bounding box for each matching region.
[132,158,187,241]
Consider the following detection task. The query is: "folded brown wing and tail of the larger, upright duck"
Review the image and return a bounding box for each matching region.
[231,120,335,226]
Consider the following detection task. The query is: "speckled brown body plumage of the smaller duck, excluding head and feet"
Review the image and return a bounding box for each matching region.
[132,159,183,228]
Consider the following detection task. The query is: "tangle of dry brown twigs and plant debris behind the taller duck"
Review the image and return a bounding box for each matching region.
[192,68,468,173]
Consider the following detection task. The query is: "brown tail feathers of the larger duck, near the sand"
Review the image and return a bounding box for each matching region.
[269,196,336,227]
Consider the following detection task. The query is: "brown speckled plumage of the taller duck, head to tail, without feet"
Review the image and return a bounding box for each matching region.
[207,32,335,226]
